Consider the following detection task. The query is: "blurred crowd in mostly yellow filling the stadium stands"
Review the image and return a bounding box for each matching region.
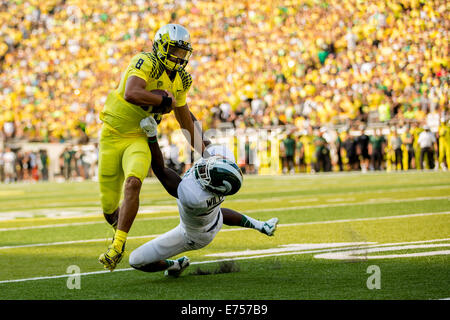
[0,0,450,180]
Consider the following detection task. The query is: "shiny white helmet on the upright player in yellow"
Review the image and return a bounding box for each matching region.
[153,23,192,71]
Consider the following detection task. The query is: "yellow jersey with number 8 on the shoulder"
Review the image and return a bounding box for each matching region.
[100,52,192,136]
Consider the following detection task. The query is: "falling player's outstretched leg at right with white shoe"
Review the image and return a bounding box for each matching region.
[220,208,278,236]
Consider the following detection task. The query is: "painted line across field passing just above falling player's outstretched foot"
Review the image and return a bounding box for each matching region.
[0,196,450,232]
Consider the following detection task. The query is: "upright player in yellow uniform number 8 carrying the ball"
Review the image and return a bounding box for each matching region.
[98,24,204,271]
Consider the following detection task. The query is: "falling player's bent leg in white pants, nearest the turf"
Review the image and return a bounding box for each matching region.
[129,225,190,276]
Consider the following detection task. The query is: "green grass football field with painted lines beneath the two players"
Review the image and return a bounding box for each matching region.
[0,172,450,300]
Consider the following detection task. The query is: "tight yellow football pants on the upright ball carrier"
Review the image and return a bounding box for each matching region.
[98,125,151,214]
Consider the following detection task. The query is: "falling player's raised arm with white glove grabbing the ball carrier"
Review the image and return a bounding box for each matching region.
[141,117,181,198]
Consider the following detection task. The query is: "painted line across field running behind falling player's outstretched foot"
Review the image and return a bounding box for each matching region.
[0,211,450,250]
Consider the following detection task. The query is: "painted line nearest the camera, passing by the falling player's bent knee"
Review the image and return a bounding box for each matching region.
[0,239,450,284]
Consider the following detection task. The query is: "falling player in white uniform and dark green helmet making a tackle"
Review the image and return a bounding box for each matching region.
[129,117,278,277]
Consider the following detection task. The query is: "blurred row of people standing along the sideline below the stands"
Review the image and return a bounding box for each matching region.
[0,121,450,183]
